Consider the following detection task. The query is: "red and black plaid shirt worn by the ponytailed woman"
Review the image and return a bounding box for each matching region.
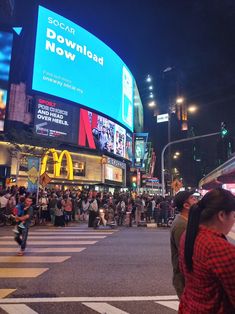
[179,226,235,314]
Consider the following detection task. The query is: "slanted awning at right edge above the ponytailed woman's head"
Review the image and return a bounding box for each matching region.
[199,156,235,190]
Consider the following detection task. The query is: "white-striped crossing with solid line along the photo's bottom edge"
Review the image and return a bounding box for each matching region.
[0,295,179,314]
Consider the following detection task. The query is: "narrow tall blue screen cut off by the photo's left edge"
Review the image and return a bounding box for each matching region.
[0,31,13,132]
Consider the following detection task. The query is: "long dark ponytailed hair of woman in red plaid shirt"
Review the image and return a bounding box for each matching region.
[184,188,235,272]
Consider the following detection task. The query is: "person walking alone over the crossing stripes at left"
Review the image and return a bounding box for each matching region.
[15,197,33,256]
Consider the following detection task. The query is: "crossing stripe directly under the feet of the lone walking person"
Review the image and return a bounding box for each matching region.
[0,247,86,254]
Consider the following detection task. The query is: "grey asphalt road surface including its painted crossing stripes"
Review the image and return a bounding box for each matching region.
[0,225,235,314]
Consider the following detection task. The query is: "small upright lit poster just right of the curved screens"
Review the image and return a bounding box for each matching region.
[134,133,148,168]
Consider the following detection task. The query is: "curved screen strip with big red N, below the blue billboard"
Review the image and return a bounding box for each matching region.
[34,97,132,160]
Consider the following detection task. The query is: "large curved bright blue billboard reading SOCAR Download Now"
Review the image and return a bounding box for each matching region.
[32,6,134,131]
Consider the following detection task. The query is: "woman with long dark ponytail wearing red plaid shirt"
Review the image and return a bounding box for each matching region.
[179,188,235,314]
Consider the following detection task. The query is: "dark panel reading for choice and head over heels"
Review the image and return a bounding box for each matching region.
[34,97,79,144]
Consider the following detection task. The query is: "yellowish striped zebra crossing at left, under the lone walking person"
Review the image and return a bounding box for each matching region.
[0,227,113,304]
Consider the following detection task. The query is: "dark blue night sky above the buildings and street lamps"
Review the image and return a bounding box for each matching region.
[11,0,235,184]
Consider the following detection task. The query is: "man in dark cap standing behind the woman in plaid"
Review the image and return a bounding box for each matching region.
[170,191,197,298]
